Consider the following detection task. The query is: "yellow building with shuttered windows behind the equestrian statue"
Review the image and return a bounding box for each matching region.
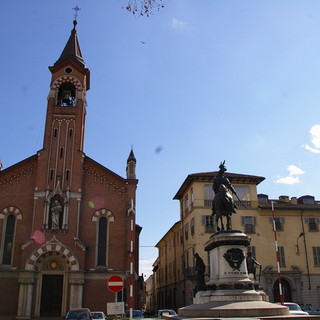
[154,172,320,309]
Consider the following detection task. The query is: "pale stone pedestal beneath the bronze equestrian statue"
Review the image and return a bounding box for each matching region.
[179,230,288,317]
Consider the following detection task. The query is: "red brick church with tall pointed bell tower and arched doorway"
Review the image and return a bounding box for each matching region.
[0,20,142,319]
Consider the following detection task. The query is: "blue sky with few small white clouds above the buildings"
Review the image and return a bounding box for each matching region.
[0,0,320,275]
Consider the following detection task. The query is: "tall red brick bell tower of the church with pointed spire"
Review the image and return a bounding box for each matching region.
[36,20,90,229]
